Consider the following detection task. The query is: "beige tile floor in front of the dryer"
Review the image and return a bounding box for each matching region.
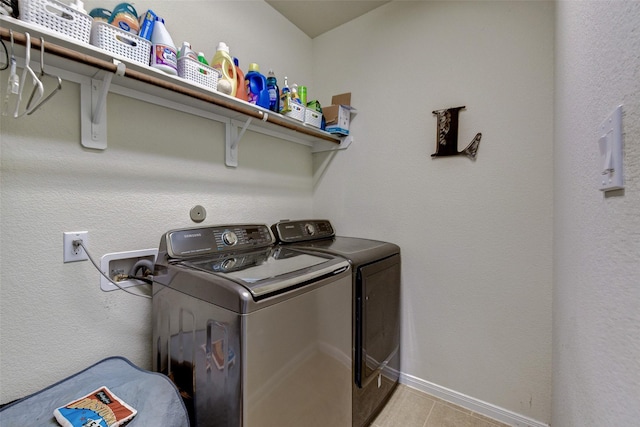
[371,384,508,427]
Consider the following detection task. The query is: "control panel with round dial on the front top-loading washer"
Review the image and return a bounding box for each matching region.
[165,224,275,258]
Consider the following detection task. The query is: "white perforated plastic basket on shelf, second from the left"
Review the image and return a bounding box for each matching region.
[91,21,151,65]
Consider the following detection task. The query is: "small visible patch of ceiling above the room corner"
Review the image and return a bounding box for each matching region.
[266,0,389,39]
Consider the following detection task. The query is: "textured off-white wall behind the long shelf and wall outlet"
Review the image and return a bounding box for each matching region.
[0,1,313,403]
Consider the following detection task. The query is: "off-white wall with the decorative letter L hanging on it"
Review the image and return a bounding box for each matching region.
[314,2,554,423]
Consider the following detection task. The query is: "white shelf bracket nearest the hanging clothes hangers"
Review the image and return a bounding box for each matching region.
[80,62,126,150]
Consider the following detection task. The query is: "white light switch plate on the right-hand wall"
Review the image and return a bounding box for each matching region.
[597,105,624,191]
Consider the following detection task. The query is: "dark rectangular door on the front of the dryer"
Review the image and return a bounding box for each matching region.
[354,255,400,388]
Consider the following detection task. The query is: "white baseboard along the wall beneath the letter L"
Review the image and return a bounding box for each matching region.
[400,373,549,427]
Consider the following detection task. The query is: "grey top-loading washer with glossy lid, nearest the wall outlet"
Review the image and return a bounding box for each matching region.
[152,224,353,427]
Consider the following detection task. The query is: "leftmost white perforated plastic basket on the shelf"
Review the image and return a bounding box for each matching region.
[19,0,93,43]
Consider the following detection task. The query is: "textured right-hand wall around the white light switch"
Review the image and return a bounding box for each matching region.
[552,1,640,427]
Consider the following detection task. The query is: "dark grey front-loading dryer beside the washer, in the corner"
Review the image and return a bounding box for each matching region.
[271,220,401,427]
